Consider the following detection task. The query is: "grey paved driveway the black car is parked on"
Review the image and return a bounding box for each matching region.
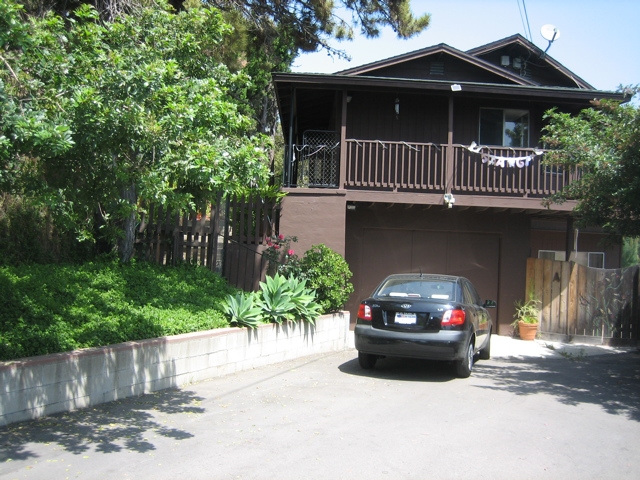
[0,336,640,480]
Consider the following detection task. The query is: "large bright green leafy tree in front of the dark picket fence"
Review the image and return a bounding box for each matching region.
[0,1,270,261]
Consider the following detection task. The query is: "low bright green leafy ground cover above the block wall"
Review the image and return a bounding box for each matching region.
[0,261,235,360]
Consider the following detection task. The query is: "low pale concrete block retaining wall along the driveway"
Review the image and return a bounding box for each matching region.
[0,312,352,426]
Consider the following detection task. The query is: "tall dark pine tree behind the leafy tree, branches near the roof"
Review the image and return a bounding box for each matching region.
[16,0,431,174]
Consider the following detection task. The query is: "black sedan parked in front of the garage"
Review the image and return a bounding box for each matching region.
[355,274,496,378]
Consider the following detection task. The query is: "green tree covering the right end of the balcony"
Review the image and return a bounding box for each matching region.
[542,93,640,237]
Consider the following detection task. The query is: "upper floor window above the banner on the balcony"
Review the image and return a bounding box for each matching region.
[480,108,529,148]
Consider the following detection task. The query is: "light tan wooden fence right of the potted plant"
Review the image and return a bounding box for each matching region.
[526,258,640,344]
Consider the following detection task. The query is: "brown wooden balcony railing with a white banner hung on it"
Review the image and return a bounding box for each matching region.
[289,139,577,198]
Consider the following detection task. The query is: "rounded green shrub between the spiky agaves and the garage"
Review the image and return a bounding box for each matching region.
[300,244,353,313]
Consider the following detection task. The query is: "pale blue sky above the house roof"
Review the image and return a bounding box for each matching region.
[293,0,640,94]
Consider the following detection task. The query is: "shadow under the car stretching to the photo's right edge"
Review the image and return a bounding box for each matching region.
[338,352,640,422]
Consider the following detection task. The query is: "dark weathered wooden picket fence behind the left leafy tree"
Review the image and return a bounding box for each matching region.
[136,194,278,290]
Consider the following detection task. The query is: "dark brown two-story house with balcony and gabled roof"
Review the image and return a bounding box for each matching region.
[273,35,625,334]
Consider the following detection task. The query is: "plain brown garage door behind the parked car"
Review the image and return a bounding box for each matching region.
[354,228,500,326]
